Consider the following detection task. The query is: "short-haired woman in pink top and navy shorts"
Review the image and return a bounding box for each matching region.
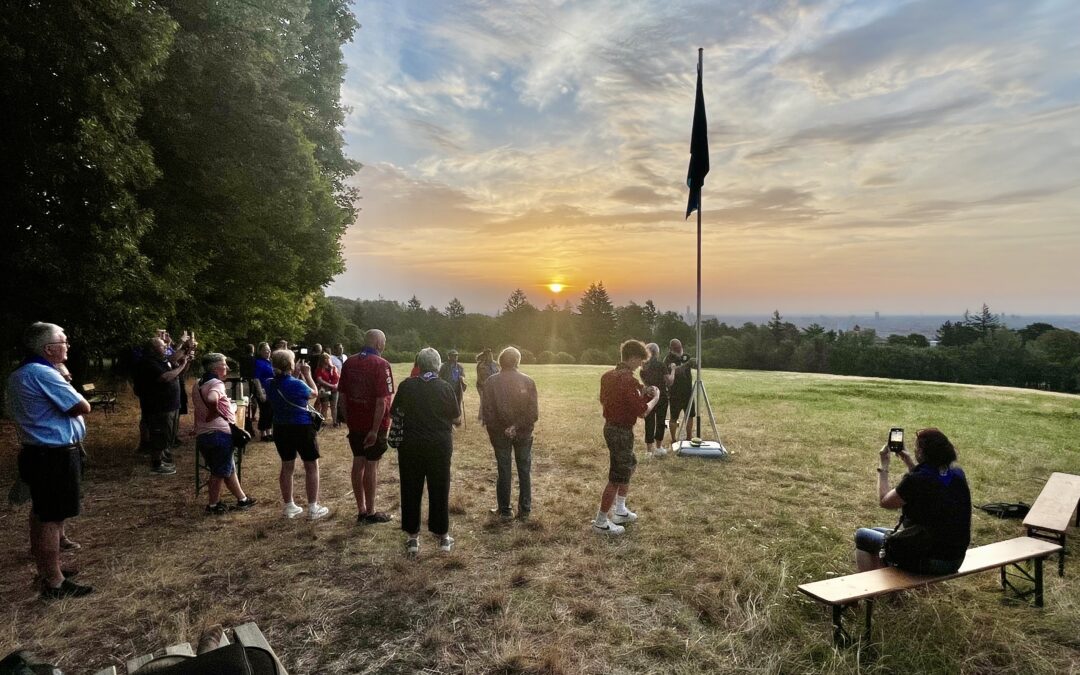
[191,348,255,515]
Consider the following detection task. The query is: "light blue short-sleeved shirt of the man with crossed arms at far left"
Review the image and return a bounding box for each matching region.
[6,360,86,447]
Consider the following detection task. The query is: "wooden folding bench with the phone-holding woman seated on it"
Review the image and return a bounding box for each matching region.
[799,537,1062,646]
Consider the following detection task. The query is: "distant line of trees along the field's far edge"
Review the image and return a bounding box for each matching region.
[319,291,1080,392]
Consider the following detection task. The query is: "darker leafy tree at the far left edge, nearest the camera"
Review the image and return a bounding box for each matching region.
[0,0,175,365]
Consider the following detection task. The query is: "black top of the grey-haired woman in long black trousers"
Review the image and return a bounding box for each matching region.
[386,373,458,454]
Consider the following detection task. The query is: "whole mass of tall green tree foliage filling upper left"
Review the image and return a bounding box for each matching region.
[0,0,357,366]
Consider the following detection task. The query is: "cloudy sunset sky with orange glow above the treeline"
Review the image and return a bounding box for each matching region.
[327,0,1080,315]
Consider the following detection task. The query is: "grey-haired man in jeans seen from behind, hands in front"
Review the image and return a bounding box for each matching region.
[476,347,540,521]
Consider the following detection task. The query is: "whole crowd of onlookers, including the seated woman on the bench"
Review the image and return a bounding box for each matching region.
[6,323,971,598]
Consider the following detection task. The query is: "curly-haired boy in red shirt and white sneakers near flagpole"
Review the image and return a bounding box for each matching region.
[593,340,660,535]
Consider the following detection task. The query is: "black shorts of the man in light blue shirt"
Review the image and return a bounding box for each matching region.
[18,445,82,523]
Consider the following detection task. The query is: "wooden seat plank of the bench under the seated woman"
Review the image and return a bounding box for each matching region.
[799,537,1062,605]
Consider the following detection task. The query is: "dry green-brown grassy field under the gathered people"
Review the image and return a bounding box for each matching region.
[0,366,1080,673]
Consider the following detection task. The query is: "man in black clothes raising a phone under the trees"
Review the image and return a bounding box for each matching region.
[135,337,191,475]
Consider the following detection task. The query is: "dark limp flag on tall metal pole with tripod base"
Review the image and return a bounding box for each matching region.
[672,49,728,459]
